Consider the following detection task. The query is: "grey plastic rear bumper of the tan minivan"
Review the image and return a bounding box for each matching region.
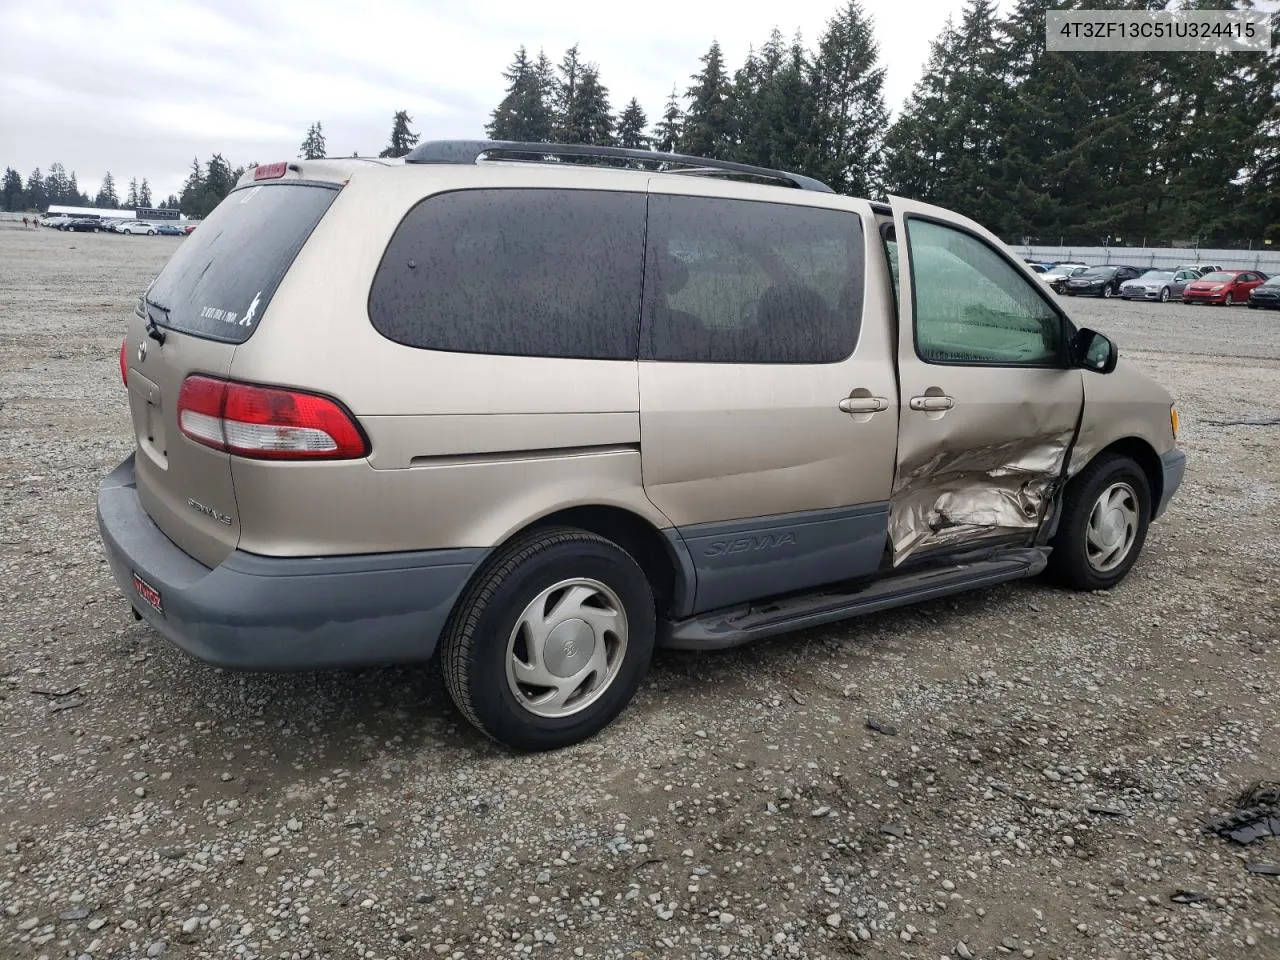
[97,456,488,671]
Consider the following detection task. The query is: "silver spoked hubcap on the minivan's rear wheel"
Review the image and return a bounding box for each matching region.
[507,579,627,719]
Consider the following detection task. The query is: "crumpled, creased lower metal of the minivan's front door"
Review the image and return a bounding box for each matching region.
[890,424,1075,566]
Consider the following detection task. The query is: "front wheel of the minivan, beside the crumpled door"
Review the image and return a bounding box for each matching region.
[1048,453,1152,591]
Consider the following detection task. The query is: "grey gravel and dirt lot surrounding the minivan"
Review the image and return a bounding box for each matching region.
[0,224,1280,960]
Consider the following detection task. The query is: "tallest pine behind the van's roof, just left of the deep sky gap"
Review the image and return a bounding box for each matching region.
[813,0,890,197]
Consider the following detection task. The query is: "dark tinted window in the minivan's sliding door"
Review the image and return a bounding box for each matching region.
[640,196,864,364]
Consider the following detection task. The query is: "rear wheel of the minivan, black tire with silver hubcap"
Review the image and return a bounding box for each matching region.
[440,527,657,750]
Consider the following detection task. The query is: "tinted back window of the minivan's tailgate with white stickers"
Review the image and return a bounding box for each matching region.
[146,183,338,343]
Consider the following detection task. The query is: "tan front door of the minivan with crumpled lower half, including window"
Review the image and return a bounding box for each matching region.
[890,197,1084,566]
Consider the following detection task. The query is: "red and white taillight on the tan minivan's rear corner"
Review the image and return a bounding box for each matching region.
[178,375,369,460]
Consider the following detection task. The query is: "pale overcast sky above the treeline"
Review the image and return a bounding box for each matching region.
[0,0,988,202]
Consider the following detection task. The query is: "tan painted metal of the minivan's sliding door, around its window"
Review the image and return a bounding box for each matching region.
[640,177,897,525]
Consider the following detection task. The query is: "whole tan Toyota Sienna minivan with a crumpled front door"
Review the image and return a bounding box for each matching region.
[99,141,1185,749]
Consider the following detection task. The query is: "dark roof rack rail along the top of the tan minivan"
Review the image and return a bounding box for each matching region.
[404,140,835,193]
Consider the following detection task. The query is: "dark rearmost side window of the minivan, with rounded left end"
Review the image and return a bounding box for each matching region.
[369,189,645,360]
